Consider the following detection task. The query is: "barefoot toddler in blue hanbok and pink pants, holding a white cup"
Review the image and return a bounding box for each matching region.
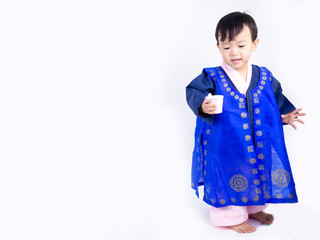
[186,12,305,233]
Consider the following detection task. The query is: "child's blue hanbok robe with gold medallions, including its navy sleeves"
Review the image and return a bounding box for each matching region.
[187,66,298,207]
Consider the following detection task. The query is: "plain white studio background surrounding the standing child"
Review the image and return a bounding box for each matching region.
[0,0,320,240]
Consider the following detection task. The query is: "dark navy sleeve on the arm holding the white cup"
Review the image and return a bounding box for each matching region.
[186,71,215,123]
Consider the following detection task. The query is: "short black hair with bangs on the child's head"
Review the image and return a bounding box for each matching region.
[215,12,258,44]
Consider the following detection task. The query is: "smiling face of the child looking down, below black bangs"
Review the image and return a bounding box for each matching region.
[217,25,259,72]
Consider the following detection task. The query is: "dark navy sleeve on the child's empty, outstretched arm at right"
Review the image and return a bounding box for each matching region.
[272,77,296,114]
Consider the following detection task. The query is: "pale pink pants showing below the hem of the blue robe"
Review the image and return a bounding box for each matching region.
[209,205,267,226]
